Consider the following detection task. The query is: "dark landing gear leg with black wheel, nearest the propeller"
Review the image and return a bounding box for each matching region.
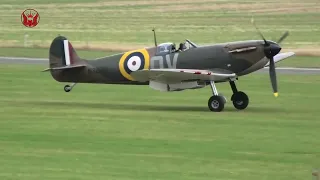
[229,81,249,110]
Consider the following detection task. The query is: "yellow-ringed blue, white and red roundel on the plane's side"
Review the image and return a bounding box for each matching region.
[119,49,150,81]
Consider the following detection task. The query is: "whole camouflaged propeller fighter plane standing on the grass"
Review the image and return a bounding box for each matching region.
[44,26,294,112]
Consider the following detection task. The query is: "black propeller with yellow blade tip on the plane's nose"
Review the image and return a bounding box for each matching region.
[251,18,289,97]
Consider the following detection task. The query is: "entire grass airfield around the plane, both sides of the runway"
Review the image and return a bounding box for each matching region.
[0,0,320,180]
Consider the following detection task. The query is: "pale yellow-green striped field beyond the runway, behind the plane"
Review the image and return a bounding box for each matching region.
[0,0,320,48]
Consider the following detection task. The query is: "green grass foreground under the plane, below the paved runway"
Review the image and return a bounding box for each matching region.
[0,64,320,180]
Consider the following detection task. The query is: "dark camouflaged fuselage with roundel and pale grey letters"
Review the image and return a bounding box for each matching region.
[48,37,273,85]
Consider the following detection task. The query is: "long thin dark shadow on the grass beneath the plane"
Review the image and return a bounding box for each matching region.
[32,101,281,113]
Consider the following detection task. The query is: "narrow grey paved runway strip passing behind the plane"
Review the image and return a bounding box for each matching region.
[0,57,320,74]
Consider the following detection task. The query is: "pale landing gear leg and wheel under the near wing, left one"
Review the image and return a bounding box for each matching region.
[208,81,226,112]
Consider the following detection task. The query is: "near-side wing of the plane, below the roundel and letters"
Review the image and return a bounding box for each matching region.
[130,69,236,83]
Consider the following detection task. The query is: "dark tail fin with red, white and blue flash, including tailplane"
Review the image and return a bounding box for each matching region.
[44,36,86,71]
